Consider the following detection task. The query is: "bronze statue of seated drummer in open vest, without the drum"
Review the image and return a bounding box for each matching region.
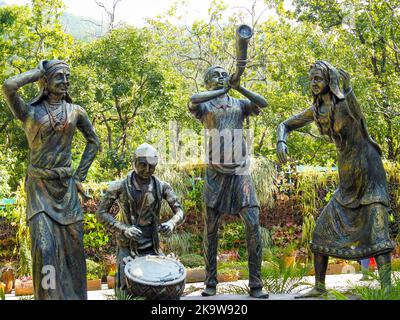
[97,143,184,291]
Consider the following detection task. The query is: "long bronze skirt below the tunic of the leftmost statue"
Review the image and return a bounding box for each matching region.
[29,212,87,300]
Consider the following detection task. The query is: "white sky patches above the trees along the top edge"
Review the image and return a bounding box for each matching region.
[3,0,280,27]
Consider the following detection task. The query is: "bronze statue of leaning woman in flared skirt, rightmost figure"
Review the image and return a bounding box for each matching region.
[277,61,394,297]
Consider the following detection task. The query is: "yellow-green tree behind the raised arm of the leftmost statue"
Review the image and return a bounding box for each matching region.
[0,0,74,188]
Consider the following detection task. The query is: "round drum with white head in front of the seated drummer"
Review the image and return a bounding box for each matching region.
[124,256,186,300]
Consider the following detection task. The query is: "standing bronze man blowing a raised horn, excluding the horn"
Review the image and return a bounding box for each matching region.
[189,59,268,298]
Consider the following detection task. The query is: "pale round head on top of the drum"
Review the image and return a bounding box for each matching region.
[124,256,186,286]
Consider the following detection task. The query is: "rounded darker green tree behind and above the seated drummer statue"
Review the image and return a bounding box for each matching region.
[74,27,173,178]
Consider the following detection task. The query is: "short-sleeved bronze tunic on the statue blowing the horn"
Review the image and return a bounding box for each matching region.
[190,95,260,214]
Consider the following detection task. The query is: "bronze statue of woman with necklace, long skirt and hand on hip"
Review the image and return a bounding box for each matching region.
[3,60,99,300]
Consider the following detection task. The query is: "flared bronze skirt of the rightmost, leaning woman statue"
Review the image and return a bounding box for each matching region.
[311,198,394,260]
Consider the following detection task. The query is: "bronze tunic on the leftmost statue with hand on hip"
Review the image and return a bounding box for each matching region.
[23,103,98,225]
